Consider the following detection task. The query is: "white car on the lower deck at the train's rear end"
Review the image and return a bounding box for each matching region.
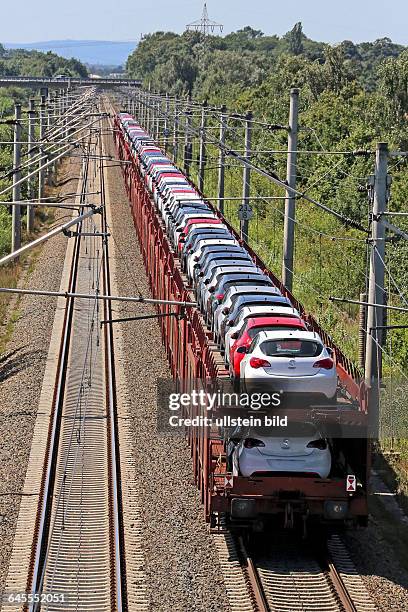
[232,422,332,478]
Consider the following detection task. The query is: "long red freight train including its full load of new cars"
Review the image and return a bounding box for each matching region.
[114,112,370,530]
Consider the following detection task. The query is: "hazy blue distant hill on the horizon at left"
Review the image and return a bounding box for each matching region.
[4,40,137,66]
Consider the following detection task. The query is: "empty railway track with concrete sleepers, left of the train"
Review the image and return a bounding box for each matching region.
[22,107,127,612]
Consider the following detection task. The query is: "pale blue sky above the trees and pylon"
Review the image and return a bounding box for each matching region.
[0,0,408,45]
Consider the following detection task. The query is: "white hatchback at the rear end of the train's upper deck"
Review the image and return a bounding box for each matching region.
[241,331,337,400]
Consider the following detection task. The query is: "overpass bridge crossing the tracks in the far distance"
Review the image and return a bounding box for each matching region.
[0,76,142,89]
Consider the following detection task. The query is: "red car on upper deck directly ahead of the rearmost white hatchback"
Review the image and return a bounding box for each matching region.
[230,314,307,379]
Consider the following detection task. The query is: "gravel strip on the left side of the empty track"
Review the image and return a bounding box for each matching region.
[0,160,79,593]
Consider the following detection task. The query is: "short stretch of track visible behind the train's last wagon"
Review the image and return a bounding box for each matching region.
[214,533,377,612]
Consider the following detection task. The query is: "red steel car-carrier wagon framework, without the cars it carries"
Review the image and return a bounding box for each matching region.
[114,117,370,528]
